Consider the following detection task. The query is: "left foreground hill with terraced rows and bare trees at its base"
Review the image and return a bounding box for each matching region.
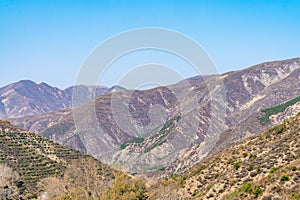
[0,120,145,200]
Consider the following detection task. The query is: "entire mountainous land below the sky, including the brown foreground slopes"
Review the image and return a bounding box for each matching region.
[0,58,300,199]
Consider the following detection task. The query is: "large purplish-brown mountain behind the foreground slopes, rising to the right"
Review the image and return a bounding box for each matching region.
[11,59,300,173]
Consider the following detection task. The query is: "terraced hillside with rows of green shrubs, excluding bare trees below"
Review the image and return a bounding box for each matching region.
[0,120,114,199]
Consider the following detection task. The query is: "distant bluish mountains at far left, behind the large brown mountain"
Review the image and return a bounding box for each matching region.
[0,80,117,119]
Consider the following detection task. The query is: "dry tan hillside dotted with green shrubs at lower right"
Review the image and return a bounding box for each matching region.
[149,113,300,199]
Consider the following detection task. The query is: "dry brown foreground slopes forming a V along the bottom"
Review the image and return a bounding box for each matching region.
[0,113,300,200]
